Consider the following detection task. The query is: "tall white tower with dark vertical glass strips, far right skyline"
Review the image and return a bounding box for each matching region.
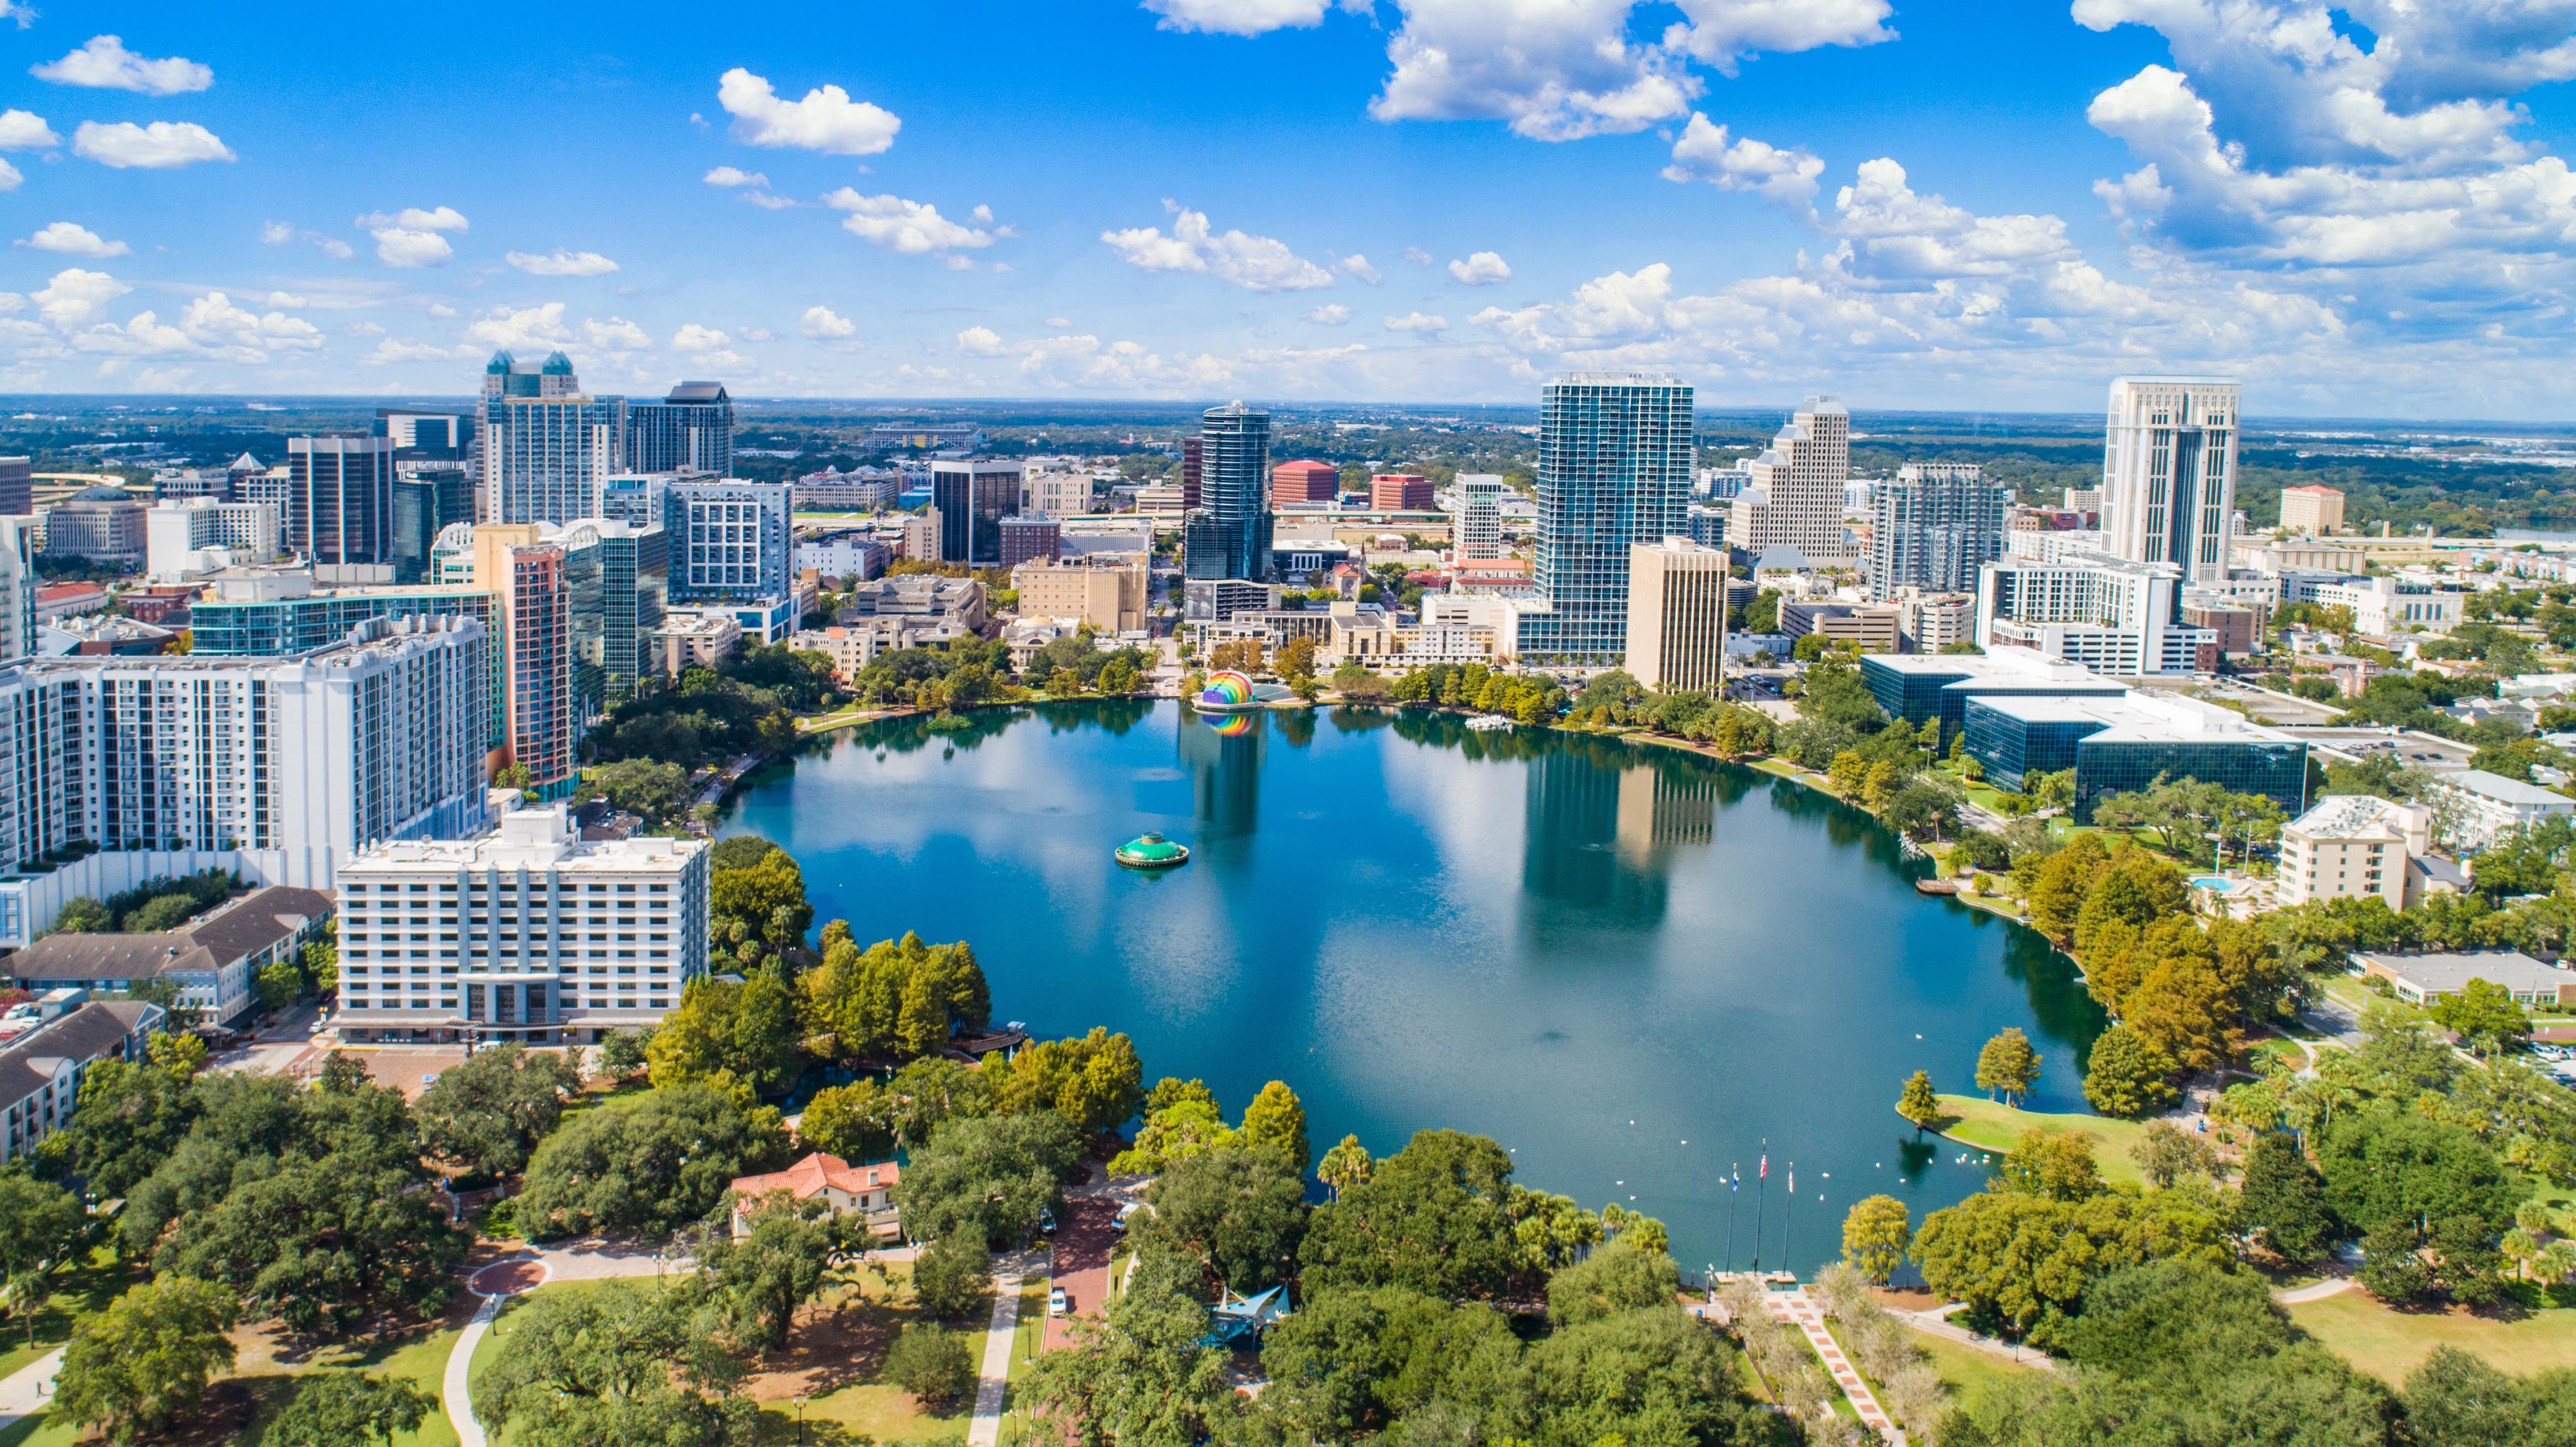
[2102,376,2236,584]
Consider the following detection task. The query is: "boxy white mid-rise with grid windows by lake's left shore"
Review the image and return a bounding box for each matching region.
[338,803,714,1043]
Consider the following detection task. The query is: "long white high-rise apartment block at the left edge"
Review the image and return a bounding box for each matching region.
[0,618,484,886]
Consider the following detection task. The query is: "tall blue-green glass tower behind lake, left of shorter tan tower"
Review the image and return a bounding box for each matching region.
[1515,371,1693,664]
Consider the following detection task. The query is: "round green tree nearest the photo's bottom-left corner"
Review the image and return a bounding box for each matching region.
[54,1277,239,1442]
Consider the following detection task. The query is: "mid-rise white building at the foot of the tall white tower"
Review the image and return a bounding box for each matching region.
[1976,553,2218,677]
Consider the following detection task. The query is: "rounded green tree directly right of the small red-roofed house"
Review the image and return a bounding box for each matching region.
[894,1110,1082,1246]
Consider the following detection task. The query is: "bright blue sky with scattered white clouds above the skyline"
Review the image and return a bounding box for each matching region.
[0,0,2576,419]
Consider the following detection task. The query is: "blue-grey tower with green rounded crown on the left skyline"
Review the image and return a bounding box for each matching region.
[482,353,628,523]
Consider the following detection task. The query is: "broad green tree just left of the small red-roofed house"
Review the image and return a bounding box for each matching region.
[518,1084,788,1239]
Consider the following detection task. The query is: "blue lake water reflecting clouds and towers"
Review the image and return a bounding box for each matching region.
[727,703,2105,1272]
